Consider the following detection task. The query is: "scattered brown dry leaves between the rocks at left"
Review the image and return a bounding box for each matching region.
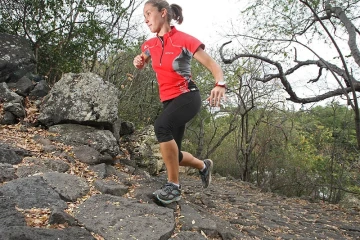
[0,103,135,240]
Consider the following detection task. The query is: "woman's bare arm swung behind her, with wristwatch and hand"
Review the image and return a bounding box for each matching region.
[194,47,226,106]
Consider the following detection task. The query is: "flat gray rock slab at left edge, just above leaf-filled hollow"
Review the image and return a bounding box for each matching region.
[0,176,67,209]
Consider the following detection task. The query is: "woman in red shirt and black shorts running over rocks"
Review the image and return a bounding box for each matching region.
[133,0,225,204]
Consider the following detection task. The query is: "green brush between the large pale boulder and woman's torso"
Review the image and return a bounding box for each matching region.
[94,39,162,128]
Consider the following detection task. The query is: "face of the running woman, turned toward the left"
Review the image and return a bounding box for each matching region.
[144,3,166,33]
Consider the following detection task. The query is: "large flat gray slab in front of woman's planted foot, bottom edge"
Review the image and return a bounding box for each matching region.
[74,194,175,240]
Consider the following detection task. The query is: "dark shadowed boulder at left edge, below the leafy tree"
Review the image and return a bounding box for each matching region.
[0,33,36,82]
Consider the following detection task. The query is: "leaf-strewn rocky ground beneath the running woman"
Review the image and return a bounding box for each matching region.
[0,125,360,240]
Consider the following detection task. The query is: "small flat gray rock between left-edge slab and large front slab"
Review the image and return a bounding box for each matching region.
[43,172,90,202]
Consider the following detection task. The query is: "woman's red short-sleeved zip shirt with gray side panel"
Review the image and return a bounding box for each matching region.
[141,26,205,102]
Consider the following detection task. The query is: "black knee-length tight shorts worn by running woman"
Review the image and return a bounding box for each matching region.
[155,91,201,161]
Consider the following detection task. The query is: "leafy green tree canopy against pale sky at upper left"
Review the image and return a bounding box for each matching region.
[0,0,141,82]
